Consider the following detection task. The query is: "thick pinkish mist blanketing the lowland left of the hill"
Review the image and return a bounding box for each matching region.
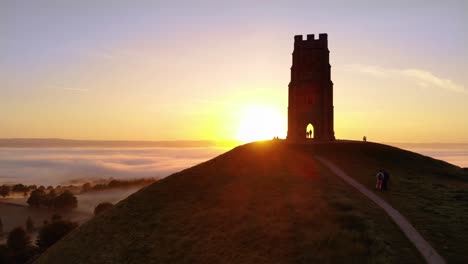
[0,147,227,185]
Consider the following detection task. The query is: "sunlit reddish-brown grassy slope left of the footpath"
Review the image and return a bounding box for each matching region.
[37,143,430,263]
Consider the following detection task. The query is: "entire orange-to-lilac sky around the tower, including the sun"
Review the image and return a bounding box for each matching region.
[0,0,468,142]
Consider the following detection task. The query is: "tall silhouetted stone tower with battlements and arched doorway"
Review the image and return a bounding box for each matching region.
[287,34,335,142]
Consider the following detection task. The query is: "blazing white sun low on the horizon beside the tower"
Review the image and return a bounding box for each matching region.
[237,106,286,142]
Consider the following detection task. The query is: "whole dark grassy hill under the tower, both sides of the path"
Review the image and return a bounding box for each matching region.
[36,141,468,263]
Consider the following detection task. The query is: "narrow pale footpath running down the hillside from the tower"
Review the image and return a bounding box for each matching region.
[316,157,445,264]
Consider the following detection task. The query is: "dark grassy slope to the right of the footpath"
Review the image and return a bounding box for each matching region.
[308,142,468,263]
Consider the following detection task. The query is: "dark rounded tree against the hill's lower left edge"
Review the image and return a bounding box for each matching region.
[36,220,78,251]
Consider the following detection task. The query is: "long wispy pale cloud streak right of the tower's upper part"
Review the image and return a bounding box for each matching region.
[346,64,466,93]
